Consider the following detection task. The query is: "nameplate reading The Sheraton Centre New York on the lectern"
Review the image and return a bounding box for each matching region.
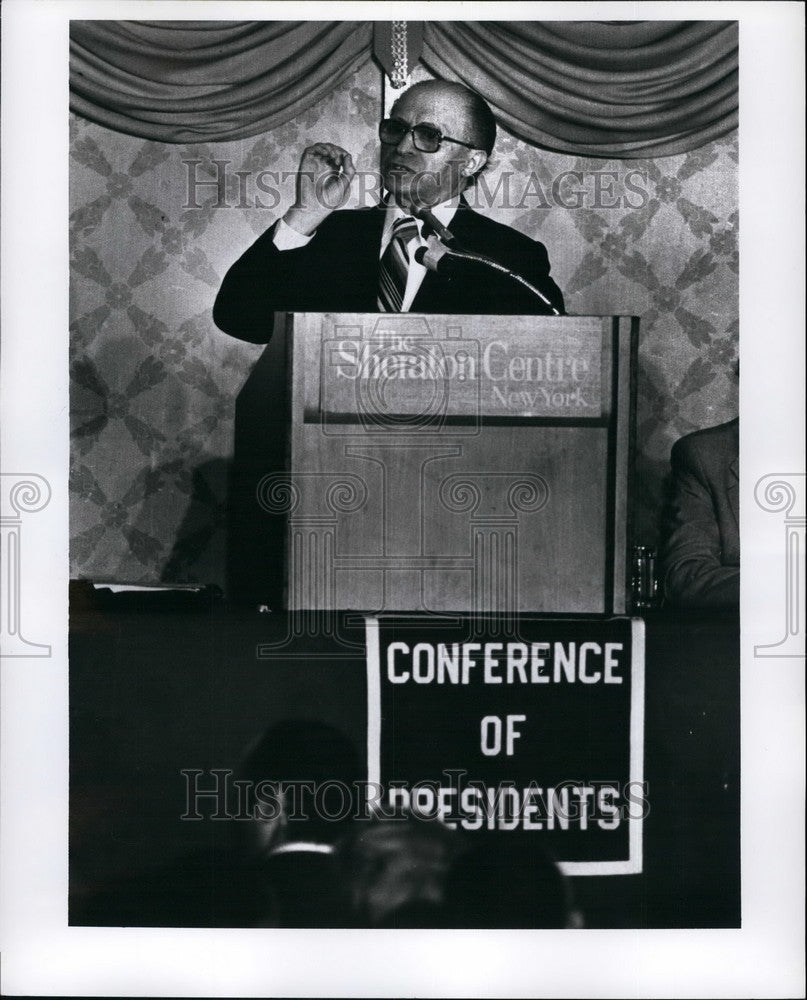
[319,315,609,421]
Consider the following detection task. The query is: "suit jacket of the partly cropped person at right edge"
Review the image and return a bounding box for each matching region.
[663,420,740,608]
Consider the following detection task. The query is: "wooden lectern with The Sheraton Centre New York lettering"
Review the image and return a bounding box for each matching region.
[259,313,638,614]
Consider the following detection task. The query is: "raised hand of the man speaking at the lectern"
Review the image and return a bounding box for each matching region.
[284,142,356,236]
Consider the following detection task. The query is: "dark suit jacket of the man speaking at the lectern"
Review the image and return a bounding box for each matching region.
[213,201,563,344]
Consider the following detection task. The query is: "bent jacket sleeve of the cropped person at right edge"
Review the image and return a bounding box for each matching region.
[662,440,740,608]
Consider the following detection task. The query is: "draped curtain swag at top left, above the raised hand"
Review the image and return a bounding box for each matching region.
[70,21,373,142]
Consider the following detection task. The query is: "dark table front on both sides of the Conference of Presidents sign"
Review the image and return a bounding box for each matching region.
[70,587,740,928]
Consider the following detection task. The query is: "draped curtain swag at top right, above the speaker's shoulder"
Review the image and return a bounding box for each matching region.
[423,21,737,158]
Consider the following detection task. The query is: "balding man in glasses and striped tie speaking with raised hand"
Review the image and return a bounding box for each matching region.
[213,81,563,344]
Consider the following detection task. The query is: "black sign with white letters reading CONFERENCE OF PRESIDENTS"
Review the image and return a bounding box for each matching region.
[367,616,647,875]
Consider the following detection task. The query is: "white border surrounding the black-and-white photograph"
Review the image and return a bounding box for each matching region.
[0,0,805,997]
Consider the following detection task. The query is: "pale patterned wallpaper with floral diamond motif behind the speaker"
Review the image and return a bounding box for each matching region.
[70,58,738,586]
